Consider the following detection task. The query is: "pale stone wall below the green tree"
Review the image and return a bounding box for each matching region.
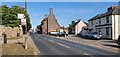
[0,25,22,38]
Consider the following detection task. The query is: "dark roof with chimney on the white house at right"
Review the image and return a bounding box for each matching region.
[88,6,120,21]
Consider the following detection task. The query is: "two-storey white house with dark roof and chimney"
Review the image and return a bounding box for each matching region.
[88,6,120,40]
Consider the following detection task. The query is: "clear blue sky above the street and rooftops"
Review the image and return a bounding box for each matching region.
[2,2,118,29]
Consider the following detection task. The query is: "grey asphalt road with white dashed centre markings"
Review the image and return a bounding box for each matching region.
[30,34,119,57]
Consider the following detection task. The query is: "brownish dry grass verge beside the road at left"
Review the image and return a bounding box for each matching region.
[2,43,34,55]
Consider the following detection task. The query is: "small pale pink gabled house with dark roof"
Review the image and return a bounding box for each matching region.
[75,20,88,35]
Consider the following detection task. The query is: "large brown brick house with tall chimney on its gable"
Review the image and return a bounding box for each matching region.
[40,8,60,34]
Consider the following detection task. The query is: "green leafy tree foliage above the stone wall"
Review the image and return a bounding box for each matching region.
[0,5,31,30]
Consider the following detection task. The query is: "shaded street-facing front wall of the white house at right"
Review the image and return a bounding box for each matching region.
[89,15,112,38]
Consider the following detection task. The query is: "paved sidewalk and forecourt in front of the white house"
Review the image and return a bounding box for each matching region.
[49,35,120,53]
